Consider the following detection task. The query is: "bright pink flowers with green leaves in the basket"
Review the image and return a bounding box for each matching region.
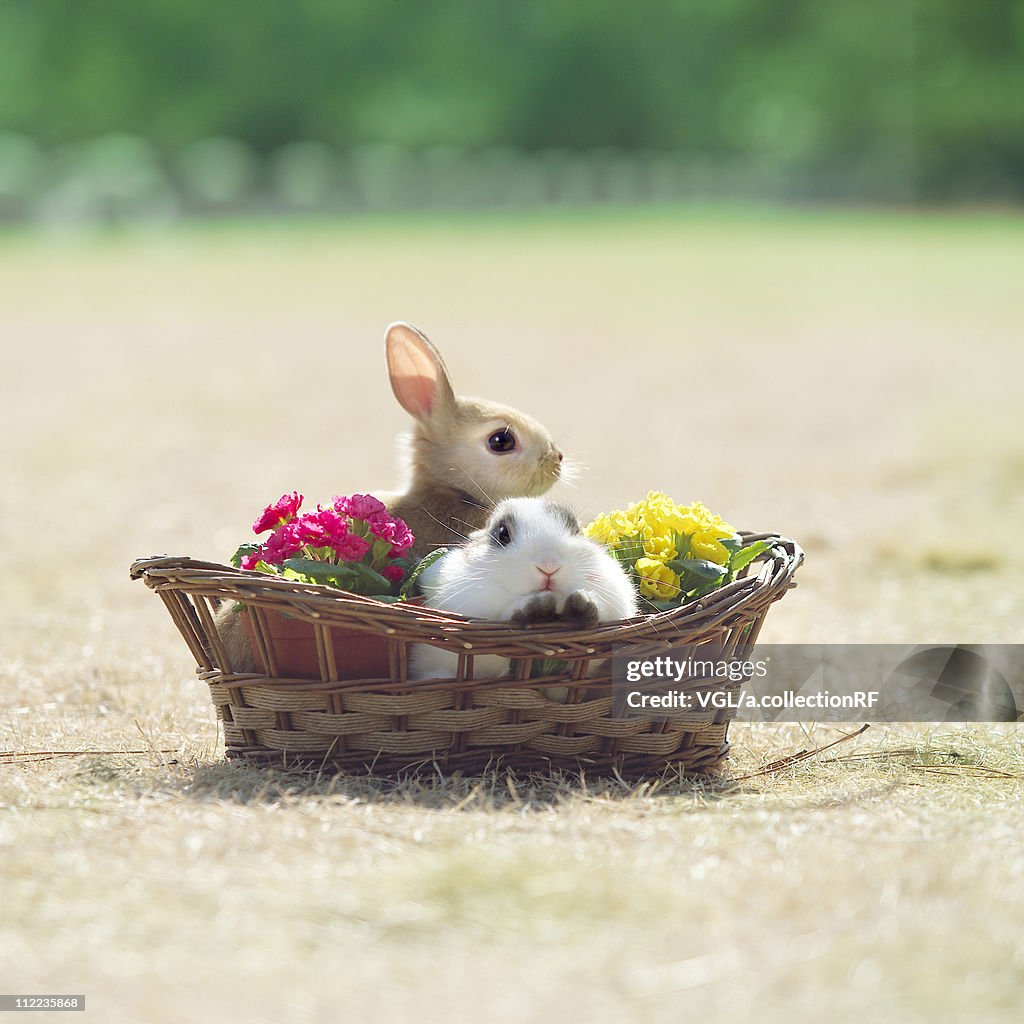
[232,490,415,597]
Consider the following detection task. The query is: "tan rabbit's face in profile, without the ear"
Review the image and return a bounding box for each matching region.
[429,398,562,502]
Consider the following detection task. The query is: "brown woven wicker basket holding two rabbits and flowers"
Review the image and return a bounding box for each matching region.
[131,534,804,775]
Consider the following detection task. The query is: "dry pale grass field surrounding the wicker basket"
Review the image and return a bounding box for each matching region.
[0,213,1024,1024]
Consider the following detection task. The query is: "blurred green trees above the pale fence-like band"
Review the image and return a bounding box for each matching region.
[0,0,1024,200]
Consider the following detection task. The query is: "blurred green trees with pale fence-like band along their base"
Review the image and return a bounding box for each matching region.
[0,0,1024,220]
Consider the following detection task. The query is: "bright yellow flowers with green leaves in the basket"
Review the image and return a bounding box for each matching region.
[584,490,765,610]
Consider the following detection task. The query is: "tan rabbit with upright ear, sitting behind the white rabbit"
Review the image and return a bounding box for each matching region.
[380,322,563,557]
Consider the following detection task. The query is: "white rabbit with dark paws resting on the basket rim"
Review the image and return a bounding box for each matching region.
[409,498,638,701]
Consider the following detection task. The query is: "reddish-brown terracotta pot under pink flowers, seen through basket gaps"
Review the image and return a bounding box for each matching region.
[241,598,423,679]
